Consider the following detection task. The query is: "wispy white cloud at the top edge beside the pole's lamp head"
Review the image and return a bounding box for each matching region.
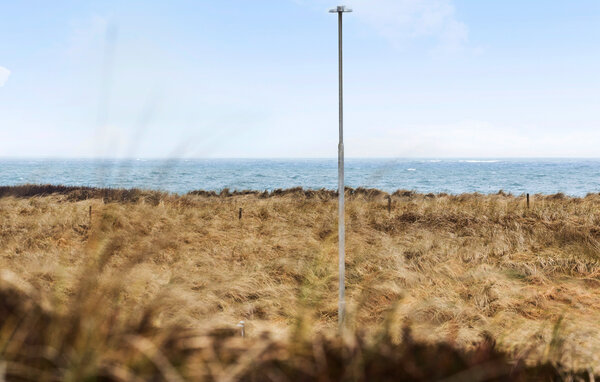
[295,0,469,52]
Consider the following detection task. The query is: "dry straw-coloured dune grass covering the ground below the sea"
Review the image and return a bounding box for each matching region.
[0,186,600,381]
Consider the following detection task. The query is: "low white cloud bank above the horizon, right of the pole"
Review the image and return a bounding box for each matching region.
[346,120,600,158]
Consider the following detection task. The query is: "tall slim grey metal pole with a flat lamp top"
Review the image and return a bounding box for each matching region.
[329,6,352,332]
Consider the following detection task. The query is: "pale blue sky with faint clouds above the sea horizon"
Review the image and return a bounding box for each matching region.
[0,0,600,158]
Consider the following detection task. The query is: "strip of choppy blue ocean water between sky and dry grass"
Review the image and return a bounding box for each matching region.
[0,159,600,196]
